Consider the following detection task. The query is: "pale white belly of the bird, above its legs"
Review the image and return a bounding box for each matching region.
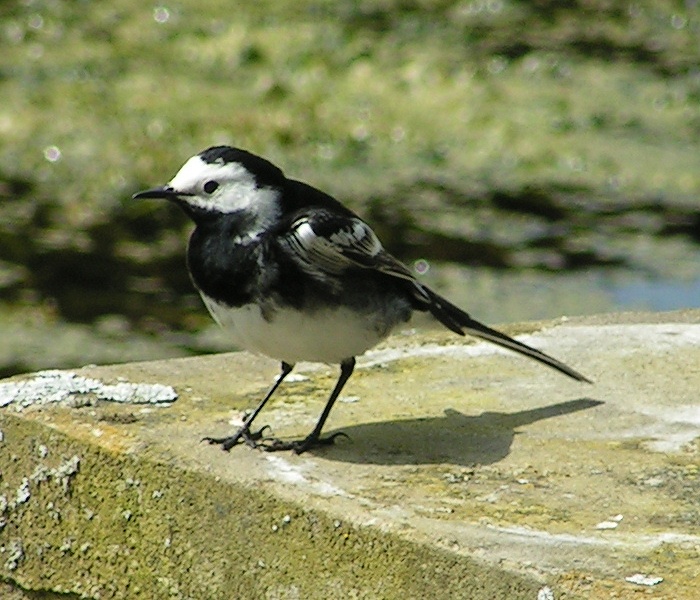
[202,294,390,364]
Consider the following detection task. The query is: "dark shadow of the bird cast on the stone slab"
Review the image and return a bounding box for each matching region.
[311,398,604,466]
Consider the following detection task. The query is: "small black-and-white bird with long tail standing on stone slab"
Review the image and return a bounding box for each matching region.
[133,146,591,454]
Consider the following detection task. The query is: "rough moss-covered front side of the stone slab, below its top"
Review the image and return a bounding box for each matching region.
[0,415,538,599]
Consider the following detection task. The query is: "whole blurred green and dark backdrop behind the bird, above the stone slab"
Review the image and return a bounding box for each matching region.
[0,0,700,372]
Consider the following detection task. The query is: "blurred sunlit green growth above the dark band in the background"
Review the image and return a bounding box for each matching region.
[0,0,700,216]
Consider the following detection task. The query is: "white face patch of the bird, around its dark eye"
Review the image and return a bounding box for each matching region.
[168,156,279,227]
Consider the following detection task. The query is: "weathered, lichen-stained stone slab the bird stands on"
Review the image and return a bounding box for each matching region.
[0,311,700,600]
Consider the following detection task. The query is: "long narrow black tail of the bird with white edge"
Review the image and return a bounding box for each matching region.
[420,286,592,383]
